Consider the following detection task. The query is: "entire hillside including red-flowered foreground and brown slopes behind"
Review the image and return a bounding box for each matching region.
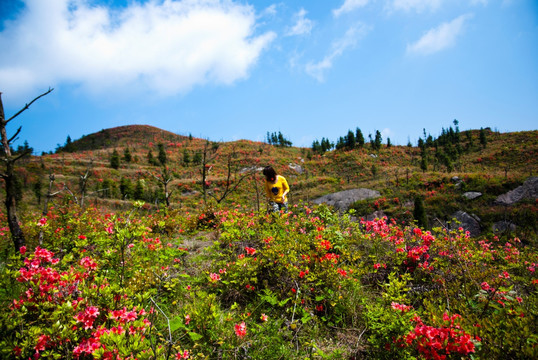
[0,127,538,360]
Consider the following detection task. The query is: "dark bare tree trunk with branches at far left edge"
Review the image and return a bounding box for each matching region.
[0,88,53,251]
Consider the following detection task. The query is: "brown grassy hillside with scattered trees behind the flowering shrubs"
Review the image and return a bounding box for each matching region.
[13,125,538,237]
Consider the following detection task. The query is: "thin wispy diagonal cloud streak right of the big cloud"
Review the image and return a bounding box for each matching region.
[305,24,370,82]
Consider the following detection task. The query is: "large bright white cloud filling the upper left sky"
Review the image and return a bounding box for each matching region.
[0,0,275,96]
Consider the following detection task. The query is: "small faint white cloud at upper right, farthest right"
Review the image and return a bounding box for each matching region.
[407,14,473,55]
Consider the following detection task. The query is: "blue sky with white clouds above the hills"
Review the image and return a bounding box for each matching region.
[0,0,538,153]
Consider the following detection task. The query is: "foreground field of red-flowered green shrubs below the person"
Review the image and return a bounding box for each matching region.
[0,202,538,359]
